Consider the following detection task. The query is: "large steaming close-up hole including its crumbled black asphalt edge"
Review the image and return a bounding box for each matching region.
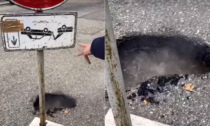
[117,35,210,104]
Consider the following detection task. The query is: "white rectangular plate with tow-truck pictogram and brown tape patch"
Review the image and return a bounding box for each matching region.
[1,12,77,51]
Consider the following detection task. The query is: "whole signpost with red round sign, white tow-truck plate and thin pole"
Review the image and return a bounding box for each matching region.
[1,0,77,126]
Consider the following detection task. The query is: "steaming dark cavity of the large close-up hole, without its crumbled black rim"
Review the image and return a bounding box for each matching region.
[117,35,210,87]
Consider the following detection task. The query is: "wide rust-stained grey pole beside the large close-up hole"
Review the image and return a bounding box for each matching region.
[105,0,132,126]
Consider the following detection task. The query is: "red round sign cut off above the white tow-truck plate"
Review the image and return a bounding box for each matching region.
[11,0,67,10]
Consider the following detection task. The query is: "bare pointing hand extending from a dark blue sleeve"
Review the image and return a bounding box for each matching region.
[78,44,91,64]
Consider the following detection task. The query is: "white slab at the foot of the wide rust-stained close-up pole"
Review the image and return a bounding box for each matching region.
[105,109,169,126]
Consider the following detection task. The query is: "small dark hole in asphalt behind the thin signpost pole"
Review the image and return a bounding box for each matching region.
[33,93,76,117]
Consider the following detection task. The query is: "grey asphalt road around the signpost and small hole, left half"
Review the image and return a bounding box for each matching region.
[0,0,104,126]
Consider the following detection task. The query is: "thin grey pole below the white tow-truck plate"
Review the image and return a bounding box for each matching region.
[37,50,46,126]
